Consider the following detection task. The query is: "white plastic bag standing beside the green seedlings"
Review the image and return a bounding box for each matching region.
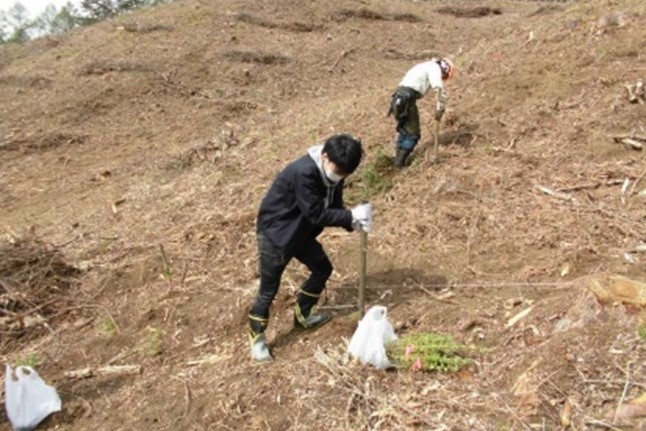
[348,305,397,368]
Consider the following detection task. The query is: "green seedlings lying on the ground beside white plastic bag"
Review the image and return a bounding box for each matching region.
[386,332,475,372]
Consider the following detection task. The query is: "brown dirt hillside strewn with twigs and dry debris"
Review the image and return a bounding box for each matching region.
[0,0,646,431]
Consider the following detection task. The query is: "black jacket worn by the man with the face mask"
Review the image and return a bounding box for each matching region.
[257,150,352,255]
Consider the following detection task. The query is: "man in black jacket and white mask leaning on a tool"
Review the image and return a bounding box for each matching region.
[249,135,372,362]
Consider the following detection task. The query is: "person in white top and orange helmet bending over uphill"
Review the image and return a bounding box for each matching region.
[388,58,456,168]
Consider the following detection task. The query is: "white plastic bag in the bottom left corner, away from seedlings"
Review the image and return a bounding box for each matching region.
[4,364,61,431]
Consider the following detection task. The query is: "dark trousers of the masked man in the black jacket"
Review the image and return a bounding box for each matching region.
[249,232,332,334]
